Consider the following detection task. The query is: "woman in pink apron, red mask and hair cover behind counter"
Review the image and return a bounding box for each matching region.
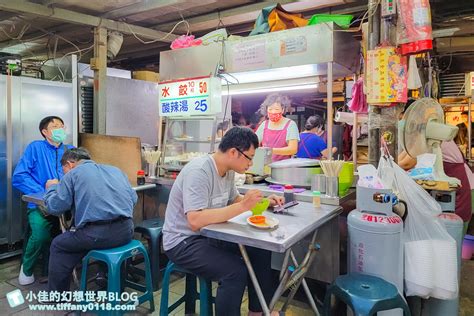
[255,93,299,161]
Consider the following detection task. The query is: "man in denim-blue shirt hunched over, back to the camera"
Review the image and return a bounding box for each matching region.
[44,148,138,292]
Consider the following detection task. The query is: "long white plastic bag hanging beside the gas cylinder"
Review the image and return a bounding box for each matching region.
[378,157,458,299]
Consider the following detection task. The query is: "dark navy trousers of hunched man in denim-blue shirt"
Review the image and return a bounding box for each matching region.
[48,218,133,292]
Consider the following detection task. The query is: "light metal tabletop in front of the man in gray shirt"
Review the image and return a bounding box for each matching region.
[201,202,342,252]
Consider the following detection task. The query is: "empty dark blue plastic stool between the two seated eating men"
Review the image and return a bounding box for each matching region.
[135,217,164,291]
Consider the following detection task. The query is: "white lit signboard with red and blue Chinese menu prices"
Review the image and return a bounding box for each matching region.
[158,76,222,116]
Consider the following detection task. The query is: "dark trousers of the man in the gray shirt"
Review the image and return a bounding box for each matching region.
[166,236,274,316]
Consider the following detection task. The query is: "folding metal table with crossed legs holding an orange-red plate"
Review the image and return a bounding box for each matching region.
[201,202,342,315]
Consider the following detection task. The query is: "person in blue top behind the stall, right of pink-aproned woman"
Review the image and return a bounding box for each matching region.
[296,115,337,159]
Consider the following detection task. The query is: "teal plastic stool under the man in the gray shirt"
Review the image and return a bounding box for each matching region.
[160,261,214,316]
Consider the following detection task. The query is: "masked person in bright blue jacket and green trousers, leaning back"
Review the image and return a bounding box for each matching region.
[12,116,73,285]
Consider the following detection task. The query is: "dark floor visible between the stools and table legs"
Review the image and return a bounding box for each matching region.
[0,257,474,316]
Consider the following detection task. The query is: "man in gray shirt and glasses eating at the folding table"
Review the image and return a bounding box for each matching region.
[163,127,284,316]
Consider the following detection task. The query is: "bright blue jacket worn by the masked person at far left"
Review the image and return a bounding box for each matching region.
[12,139,74,208]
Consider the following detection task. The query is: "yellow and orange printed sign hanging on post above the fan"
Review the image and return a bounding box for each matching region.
[367,47,408,105]
